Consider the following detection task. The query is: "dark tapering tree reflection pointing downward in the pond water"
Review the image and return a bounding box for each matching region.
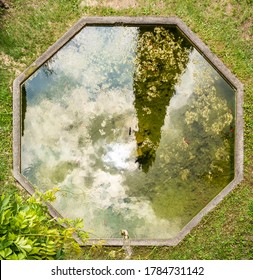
[134,27,190,173]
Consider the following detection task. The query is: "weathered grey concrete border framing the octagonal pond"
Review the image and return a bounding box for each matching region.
[13,17,244,246]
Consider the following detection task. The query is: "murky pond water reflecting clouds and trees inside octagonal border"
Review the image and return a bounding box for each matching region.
[21,26,235,238]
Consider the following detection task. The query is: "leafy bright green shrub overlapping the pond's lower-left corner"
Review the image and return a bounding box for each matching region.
[0,190,88,260]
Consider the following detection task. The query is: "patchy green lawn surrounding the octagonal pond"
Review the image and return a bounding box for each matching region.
[0,0,253,259]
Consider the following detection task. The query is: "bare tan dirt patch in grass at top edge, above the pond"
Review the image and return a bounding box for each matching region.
[80,0,139,10]
